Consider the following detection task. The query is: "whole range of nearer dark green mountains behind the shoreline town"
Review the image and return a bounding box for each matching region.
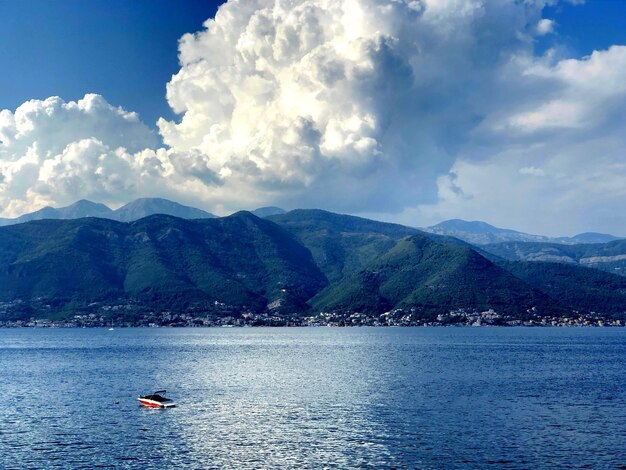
[0,206,626,319]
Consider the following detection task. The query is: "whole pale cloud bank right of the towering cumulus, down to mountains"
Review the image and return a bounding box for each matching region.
[412,46,626,235]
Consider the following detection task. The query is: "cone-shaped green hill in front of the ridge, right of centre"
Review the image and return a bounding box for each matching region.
[312,235,551,315]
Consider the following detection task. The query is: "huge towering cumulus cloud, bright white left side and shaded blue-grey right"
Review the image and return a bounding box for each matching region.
[159,0,543,212]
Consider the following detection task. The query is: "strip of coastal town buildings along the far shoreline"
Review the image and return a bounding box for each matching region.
[0,304,626,328]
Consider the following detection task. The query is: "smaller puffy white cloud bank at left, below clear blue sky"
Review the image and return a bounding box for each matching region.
[0,94,222,216]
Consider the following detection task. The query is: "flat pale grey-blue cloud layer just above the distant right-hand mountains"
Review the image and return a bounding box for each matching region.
[412,140,626,236]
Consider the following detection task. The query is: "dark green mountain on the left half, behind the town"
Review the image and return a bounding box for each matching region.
[0,212,326,311]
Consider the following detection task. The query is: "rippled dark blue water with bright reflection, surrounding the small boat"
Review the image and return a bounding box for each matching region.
[0,328,626,469]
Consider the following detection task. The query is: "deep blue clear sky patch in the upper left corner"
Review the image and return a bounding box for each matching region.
[0,0,221,124]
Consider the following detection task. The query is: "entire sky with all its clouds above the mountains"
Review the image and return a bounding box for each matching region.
[0,0,626,236]
